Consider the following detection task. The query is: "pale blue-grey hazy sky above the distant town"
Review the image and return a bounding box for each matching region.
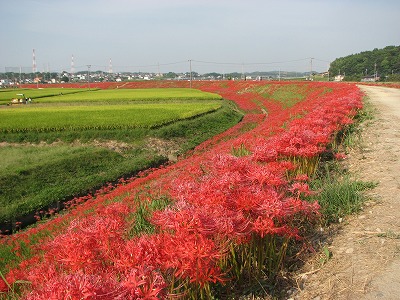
[0,0,400,74]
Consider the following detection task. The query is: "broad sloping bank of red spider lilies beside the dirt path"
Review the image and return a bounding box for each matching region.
[0,81,370,299]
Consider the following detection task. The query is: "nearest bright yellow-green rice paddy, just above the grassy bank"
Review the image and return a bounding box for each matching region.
[0,101,222,133]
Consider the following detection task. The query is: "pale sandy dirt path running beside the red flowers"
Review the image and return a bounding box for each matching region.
[292,86,400,300]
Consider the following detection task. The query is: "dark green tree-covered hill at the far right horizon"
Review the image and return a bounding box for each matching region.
[329,46,400,81]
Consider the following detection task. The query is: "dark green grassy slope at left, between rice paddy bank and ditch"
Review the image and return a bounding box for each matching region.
[0,146,165,222]
